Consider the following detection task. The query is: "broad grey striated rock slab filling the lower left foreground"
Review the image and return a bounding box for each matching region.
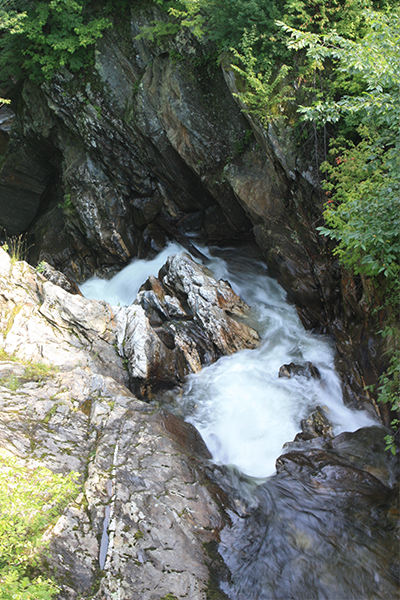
[0,363,223,600]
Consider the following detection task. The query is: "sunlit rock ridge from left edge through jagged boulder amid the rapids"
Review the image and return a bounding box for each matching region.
[0,244,259,398]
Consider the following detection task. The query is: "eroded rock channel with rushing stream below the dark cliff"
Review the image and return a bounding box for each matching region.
[0,241,398,600]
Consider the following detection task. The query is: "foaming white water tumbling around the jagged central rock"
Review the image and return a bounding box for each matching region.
[81,245,375,478]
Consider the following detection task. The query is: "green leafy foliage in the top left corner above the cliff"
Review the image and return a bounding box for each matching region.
[0,0,111,82]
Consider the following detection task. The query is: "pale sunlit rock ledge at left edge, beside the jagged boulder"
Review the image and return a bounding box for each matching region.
[0,249,127,383]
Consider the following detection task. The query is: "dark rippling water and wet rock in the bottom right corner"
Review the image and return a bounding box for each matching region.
[220,427,399,600]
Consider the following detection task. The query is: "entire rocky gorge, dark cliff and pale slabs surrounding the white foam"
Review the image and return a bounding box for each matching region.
[0,4,398,600]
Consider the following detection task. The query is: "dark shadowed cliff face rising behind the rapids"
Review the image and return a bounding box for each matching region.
[0,8,386,412]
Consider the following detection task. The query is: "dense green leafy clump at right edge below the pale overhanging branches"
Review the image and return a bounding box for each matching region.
[318,131,400,288]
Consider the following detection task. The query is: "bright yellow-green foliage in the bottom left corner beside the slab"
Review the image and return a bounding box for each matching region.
[0,451,79,600]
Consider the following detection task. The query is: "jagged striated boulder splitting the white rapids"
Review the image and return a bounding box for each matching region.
[116,254,259,397]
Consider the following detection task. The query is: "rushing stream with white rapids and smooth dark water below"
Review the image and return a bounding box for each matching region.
[81,244,397,600]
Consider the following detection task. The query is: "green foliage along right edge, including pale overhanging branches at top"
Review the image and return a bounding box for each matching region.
[281,11,400,453]
